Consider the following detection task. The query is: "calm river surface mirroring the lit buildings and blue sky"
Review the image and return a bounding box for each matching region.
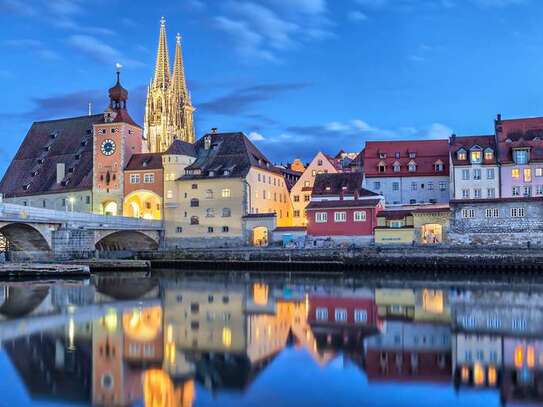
[0,277,543,407]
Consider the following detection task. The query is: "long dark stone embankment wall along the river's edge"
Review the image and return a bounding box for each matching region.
[138,247,543,276]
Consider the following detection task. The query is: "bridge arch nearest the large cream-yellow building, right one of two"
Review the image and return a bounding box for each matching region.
[95,230,159,251]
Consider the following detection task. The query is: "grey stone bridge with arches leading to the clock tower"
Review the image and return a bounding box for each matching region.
[0,203,163,258]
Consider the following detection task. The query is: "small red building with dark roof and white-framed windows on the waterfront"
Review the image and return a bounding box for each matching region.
[306,172,384,242]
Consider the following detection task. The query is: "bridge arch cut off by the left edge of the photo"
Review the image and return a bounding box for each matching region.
[0,223,51,252]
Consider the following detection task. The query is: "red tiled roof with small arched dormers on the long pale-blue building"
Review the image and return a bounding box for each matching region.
[363,140,449,177]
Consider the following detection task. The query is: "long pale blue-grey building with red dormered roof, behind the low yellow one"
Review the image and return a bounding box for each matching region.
[363,140,449,205]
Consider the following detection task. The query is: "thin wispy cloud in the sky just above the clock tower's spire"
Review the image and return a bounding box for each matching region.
[66,34,144,67]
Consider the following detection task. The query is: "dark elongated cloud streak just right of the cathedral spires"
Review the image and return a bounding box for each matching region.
[198,83,309,115]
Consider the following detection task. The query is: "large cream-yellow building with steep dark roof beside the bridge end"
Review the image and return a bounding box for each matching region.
[165,133,292,247]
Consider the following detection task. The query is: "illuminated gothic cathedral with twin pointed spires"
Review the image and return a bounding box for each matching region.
[144,17,195,153]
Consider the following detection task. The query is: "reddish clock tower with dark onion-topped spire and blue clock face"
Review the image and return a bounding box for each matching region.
[92,65,143,216]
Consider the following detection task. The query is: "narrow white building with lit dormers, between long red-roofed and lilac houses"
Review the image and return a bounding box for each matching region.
[449,135,500,199]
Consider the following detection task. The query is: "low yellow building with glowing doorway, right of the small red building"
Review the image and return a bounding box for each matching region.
[375,205,450,245]
